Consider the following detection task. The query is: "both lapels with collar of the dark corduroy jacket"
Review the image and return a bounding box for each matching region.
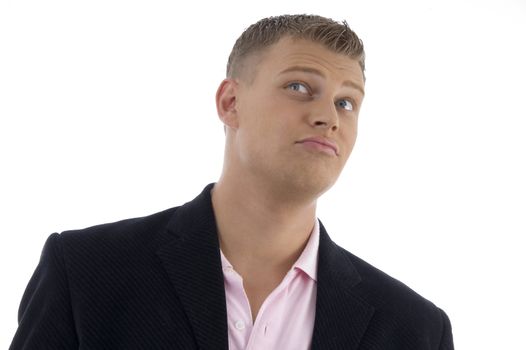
[157,184,374,350]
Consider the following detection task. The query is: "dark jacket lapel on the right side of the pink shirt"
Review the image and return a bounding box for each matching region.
[312,223,374,350]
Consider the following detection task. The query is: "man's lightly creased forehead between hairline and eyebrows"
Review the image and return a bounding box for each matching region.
[258,37,364,86]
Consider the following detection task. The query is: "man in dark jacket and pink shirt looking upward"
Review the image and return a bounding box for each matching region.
[11,15,453,350]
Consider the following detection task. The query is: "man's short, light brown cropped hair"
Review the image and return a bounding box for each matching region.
[226,14,365,80]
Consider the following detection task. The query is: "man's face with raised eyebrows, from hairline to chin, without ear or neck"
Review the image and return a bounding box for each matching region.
[227,37,364,198]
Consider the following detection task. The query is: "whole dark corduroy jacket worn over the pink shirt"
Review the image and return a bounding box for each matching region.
[10,184,453,350]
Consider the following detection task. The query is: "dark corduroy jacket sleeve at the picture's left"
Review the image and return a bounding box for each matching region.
[9,233,79,350]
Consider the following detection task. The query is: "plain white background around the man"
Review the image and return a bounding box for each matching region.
[0,0,526,350]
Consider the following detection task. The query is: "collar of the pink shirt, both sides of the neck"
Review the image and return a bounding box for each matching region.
[220,219,320,282]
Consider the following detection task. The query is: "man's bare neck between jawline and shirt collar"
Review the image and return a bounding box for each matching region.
[212,177,316,275]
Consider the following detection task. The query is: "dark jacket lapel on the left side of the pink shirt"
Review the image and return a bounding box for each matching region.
[153,184,228,350]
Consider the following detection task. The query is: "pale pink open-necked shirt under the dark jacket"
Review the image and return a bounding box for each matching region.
[221,220,320,350]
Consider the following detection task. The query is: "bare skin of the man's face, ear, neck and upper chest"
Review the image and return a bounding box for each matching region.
[212,37,364,319]
